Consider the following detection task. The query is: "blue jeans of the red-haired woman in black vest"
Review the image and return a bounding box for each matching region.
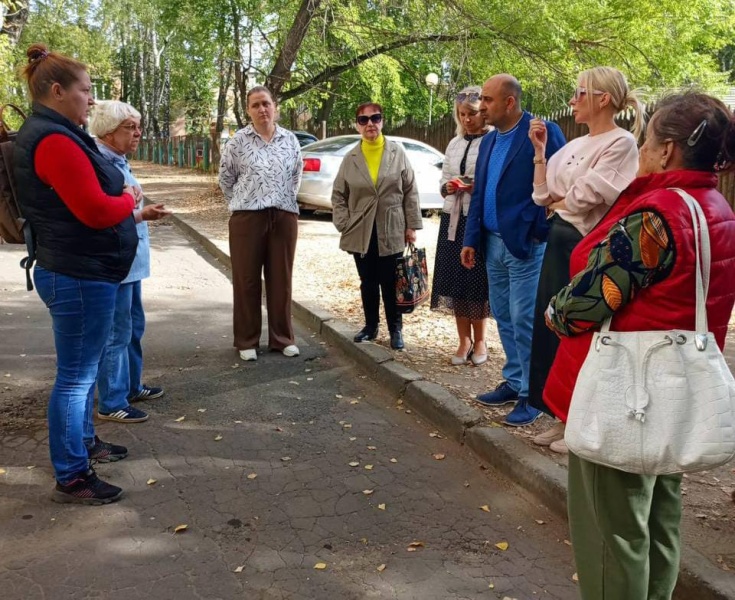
[33,266,119,483]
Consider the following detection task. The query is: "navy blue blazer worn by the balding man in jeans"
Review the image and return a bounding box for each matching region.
[464,111,566,260]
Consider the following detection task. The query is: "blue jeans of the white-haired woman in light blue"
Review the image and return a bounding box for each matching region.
[97,281,145,413]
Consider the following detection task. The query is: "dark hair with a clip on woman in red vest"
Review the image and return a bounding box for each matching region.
[651,92,735,171]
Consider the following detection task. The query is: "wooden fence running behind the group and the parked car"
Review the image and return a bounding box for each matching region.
[135,105,735,208]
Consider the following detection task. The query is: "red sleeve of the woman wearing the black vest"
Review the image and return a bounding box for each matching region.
[33,133,135,229]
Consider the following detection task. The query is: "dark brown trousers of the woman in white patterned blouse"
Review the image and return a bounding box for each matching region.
[230,208,299,350]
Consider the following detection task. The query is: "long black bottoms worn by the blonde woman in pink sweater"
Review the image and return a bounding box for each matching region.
[528,215,582,414]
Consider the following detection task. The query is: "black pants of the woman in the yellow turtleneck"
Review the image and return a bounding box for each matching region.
[353,227,403,332]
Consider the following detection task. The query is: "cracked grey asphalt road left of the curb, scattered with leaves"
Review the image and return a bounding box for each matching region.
[0,224,577,600]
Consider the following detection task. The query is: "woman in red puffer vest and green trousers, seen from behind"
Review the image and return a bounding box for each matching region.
[544,93,735,600]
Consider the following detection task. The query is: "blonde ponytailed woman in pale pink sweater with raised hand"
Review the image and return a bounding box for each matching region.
[528,67,644,453]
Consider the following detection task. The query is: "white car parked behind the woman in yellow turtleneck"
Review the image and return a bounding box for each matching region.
[297,135,444,211]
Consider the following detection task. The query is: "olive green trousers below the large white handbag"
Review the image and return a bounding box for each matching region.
[568,453,681,600]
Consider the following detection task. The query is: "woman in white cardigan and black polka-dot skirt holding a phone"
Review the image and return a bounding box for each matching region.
[431,86,490,365]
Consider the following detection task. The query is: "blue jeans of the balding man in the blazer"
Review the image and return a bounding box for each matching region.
[485,233,546,397]
